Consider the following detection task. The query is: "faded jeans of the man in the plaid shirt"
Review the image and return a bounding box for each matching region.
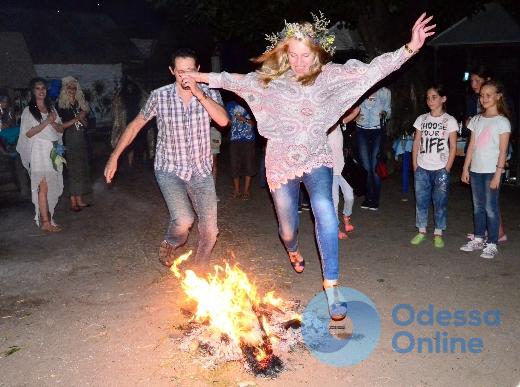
[155,170,218,262]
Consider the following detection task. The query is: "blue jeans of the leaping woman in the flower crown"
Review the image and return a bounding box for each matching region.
[271,167,339,280]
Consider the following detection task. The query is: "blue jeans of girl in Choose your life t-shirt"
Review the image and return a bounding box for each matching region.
[414,166,450,230]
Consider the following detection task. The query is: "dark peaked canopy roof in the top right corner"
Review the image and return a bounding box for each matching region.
[428,3,520,47]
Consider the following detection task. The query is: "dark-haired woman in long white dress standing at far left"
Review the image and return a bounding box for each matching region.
[16,78,63,232]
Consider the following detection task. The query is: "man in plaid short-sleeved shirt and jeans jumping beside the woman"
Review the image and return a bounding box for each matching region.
[105,49,229,266]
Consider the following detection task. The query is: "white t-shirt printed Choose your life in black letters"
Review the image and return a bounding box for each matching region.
[413,113,459,171]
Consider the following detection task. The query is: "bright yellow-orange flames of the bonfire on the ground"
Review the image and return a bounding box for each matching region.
[170,251,283,354]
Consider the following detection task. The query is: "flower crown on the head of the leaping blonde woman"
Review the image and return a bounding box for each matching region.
[265,11,336,56]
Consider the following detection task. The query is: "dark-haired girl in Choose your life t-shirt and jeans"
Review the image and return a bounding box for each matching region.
[410,85,459,248]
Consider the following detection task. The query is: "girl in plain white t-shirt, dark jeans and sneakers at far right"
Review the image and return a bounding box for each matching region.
[460,80,511,259]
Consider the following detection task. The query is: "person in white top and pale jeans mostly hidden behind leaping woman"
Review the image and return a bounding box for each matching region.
[327,106,359,239]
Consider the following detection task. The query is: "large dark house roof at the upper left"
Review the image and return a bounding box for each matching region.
[0,8,141,64]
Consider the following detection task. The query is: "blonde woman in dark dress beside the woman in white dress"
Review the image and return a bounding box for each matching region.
[57,77,90,212]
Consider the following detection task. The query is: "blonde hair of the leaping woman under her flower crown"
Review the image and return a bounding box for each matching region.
[251,32,331,86]
